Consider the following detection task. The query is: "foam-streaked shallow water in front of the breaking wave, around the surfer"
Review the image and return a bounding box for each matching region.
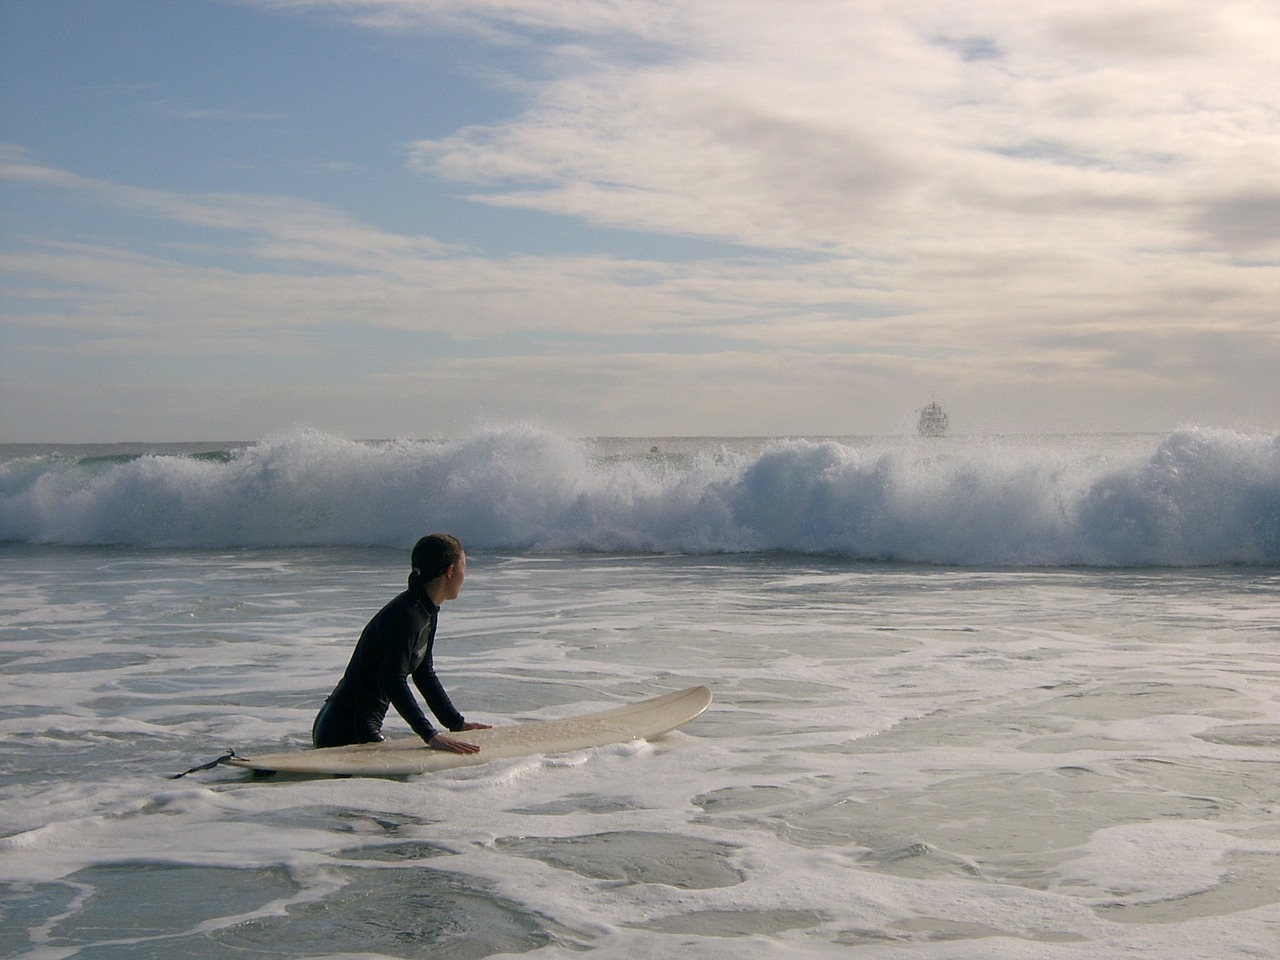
[0,545,1280,960]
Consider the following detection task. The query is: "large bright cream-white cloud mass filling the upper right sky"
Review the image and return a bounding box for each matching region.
[396,0,1280,271]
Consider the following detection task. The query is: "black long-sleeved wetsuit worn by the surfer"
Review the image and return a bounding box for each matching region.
[311,590,466,746]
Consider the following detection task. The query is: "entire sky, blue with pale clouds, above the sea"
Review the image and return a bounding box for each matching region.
[0,0,1280,443]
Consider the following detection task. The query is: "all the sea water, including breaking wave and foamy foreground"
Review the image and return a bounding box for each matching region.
[0,428,1280,960]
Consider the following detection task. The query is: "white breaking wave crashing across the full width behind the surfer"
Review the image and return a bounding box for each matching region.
[0,426,1280,566]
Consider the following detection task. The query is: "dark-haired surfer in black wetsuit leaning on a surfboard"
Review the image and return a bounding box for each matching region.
[311,534,489,754]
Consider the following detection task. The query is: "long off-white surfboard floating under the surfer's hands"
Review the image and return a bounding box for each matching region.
[227,686,712,777]
